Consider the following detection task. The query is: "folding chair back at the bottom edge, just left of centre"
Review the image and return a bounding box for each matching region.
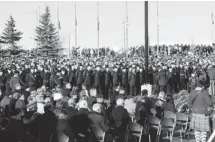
[90,127,105,142]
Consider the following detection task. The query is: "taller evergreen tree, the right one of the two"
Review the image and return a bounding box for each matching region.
[35,7,61,55]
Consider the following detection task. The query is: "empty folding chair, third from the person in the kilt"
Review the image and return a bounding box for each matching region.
[147,115,161,142]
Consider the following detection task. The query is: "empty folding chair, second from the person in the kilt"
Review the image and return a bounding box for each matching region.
[159,117,176,142]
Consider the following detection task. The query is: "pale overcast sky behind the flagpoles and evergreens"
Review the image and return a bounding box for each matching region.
[0,1,215,49]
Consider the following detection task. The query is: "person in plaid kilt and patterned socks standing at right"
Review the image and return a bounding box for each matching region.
[187,75,213,142]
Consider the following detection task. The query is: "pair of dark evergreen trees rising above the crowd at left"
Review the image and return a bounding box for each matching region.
[0,6,62,56]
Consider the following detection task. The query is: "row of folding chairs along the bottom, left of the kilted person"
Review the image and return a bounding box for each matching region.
[92,111,189,142]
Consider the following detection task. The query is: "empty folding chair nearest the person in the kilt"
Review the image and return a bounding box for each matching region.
[174,112,189,142]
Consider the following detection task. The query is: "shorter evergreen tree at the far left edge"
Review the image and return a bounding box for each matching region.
[1,15,22,50]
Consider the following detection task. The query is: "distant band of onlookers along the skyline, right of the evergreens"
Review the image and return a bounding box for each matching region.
[67,44,213,58]
